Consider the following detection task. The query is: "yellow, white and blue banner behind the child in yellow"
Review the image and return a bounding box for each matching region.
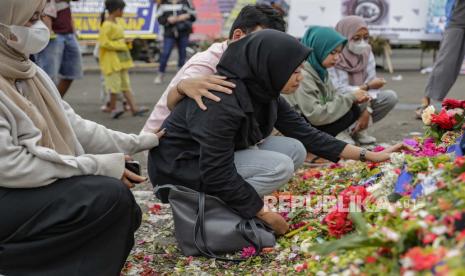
[71,0,158,39]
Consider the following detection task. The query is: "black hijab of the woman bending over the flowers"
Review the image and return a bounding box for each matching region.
[217,30,310,148]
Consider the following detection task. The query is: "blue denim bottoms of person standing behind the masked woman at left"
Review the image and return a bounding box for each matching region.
[35,34,83,83]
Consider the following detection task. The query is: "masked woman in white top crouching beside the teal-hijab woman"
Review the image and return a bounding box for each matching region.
[328,16,397,144]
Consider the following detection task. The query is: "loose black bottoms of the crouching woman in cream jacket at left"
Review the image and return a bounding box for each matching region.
[0,176,142,275]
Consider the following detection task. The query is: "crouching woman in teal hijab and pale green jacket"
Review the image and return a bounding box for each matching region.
[285,26,370,144]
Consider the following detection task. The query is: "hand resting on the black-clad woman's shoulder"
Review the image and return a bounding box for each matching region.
[178,75,236,110]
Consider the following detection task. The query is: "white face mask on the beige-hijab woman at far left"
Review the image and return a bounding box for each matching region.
[1,20,50,56]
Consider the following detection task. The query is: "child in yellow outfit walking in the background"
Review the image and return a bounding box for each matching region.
[98,0,148,119]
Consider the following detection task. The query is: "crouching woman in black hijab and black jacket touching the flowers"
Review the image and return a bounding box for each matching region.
[149,30,402,234]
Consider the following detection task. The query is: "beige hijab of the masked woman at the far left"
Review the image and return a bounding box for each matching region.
[0,0,76,155]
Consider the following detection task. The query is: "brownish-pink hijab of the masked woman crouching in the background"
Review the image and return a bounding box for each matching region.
[335,16,371,86]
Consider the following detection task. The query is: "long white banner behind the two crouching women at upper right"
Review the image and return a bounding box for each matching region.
[288,0,445,42]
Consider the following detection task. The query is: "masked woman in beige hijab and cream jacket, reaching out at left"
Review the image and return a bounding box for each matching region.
[0,0,161,275]
